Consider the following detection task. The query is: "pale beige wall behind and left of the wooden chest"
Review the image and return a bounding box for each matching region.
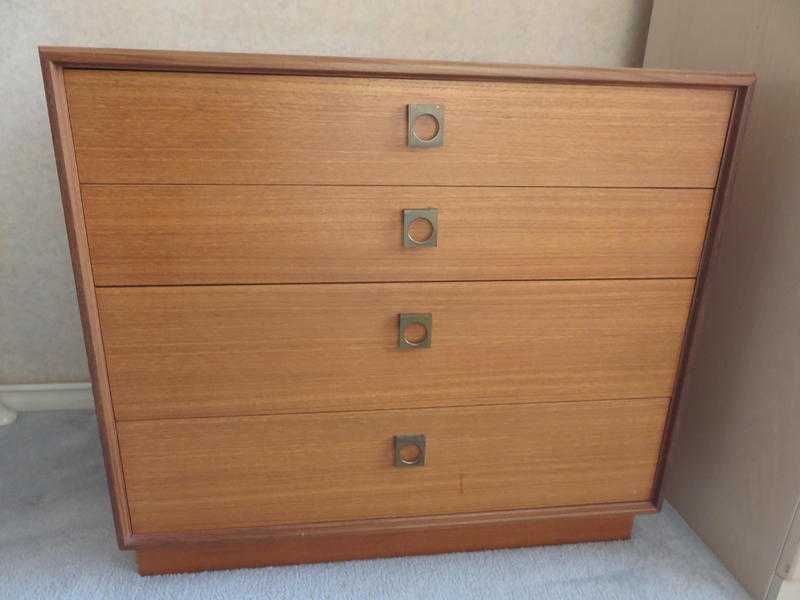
[0,0,652,384]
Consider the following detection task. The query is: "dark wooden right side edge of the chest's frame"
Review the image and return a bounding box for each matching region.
[653,76,756,510]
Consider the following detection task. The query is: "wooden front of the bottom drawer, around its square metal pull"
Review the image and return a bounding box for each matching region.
[118,399,668,533]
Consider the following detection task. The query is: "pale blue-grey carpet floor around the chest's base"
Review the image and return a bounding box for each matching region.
[0,411,749,600]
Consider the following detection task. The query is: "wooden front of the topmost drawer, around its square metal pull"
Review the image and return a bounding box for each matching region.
[65,69,734,188]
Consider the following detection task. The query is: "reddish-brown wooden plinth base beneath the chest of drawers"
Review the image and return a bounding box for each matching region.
[136,515,633,575]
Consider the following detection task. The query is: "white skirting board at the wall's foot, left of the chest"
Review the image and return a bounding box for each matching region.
[0,383,94,425]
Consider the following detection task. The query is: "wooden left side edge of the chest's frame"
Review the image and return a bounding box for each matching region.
[39,53,132,549]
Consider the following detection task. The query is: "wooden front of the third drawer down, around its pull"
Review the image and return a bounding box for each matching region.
[97,279,694,420]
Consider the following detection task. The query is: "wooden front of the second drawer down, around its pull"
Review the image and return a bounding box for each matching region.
[82,185,712,286]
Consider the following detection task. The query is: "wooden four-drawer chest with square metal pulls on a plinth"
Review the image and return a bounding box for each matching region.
[41,48,753,573]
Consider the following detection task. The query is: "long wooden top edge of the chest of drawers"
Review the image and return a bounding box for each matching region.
[39,46,755,87]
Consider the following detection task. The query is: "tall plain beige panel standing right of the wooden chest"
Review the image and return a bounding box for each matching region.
[645,0,800,598]
